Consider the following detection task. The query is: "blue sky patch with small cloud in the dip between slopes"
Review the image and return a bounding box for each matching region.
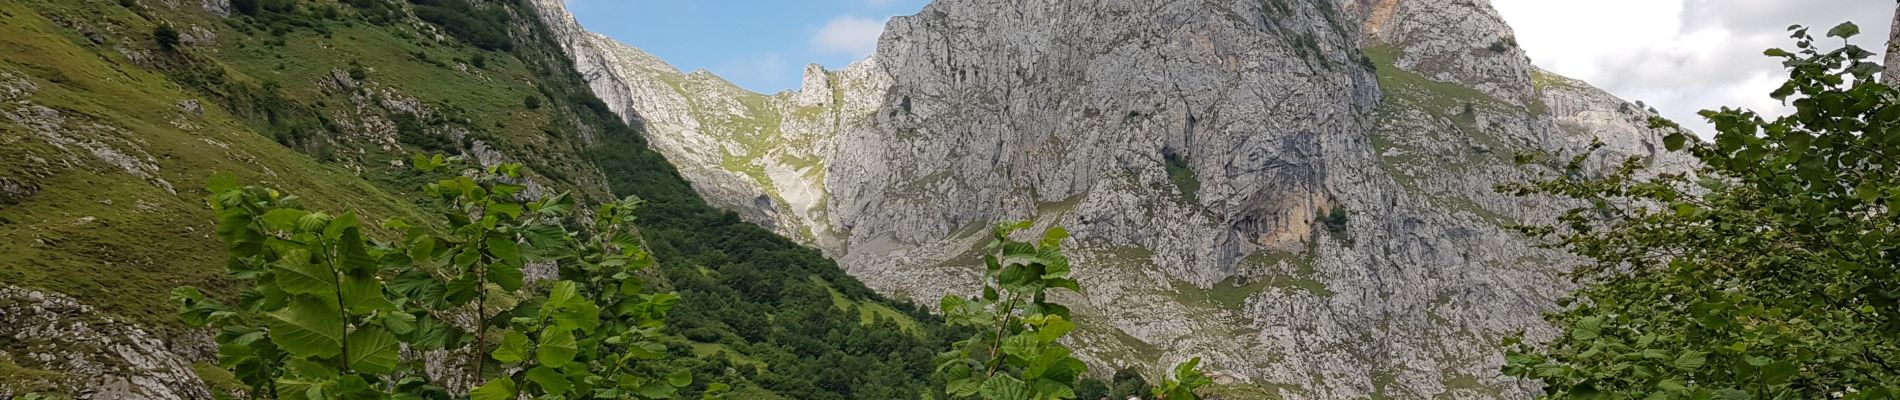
[566,0,927,93]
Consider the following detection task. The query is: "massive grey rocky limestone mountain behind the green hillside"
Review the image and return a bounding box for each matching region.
[536,0,1689,398]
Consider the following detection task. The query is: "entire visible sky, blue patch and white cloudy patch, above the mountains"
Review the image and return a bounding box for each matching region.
[568,0,1894,135]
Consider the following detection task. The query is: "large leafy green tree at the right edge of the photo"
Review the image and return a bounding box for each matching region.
[1499,23,1900,398]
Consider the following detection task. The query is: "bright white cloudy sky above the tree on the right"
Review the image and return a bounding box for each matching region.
[1492,0,1894,135]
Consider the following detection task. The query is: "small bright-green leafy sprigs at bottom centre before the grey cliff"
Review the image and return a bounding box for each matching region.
[937,222,1212,400]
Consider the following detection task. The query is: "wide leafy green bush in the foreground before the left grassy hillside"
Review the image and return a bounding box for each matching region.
[177,155,718,400]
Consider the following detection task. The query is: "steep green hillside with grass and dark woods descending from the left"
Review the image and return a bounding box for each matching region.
[0,0,941,398]
